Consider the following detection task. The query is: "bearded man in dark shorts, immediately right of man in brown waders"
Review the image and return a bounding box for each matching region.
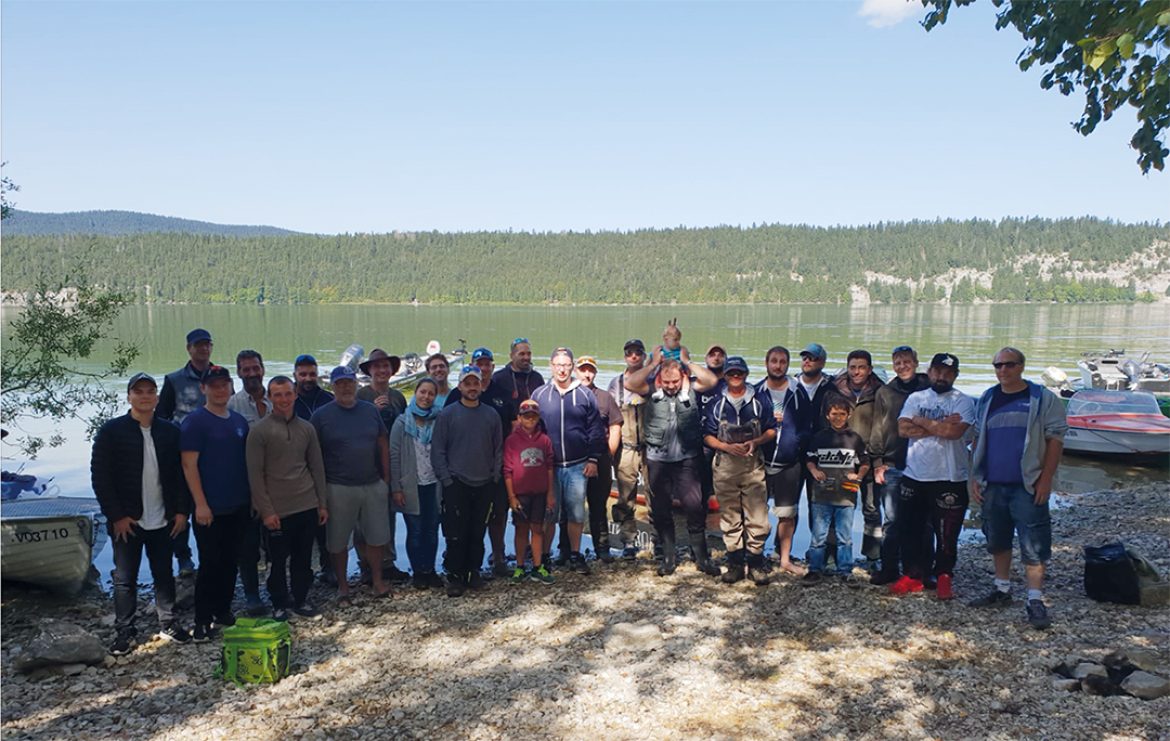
[756,345,805,576]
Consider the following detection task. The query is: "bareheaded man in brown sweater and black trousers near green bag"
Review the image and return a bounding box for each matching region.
[247,376,329,620]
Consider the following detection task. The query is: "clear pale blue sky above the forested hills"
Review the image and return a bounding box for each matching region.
[0,0,1170,233]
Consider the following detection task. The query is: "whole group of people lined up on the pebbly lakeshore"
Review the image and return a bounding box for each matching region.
[91,321,1066,653]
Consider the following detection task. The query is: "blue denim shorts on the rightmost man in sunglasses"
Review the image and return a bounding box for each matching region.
[983,483,1052,565]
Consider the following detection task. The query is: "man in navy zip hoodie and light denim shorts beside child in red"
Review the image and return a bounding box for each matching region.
[531,348,606,574]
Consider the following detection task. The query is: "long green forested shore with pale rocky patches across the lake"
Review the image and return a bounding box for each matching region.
[2,218,1170,303]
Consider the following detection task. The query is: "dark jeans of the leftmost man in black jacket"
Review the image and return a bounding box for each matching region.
[113,524,174,632]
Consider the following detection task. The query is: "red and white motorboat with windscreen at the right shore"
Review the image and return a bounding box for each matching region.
[1065,389,1170,457]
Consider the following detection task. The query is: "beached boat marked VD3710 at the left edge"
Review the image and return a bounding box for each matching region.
[0,471,109,594]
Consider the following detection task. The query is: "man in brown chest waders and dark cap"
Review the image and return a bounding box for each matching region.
[703,356,776,585]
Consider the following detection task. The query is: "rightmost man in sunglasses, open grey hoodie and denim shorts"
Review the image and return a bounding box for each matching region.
[970,348,1068,630]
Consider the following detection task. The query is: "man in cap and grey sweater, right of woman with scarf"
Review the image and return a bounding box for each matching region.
[431,365,504,597]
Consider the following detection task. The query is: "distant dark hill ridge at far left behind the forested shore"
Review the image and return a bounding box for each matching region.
[4,208,296,236]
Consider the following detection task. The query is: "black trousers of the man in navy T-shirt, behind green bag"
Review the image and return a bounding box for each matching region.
[195,505,253,625]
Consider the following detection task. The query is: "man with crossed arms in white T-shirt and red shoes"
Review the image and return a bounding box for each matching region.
[889,352,975,599]
